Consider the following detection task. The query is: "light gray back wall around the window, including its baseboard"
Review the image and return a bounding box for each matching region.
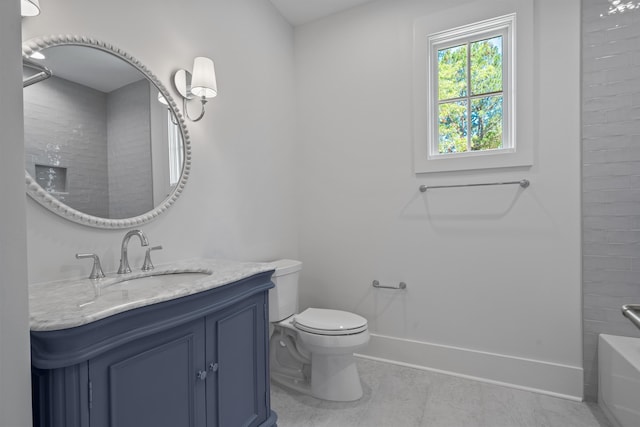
[296,0,584,398]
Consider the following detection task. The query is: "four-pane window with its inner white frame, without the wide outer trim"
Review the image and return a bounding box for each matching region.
[428,15,514,158]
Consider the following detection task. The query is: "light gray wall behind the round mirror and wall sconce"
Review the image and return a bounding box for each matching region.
[21,0,298,283]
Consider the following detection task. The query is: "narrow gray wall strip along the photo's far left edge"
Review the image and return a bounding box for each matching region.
[0,0,31,427]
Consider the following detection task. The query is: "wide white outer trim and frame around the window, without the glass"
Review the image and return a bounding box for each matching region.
[413,0,535,173]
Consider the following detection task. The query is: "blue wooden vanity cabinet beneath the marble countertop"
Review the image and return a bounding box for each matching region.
[31,272,276,427]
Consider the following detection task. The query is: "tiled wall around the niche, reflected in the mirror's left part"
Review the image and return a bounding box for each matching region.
[24,73,109,217]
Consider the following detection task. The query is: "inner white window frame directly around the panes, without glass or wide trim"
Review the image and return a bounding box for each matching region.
[427,14,515,159]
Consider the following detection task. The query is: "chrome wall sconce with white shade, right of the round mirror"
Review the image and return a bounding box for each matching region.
[173,56,218,122]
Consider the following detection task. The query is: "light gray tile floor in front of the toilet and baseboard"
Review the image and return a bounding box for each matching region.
[271,358,612,427]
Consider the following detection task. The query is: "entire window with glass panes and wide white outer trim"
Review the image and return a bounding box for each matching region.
[413,0,535,173]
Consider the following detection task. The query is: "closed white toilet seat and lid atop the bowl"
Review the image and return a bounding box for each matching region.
[292,308,367,336]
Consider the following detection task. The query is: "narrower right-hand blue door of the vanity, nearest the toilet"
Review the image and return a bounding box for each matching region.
[206,293,270,427]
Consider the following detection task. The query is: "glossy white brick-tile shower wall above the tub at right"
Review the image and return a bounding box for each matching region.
[582,0,640,400]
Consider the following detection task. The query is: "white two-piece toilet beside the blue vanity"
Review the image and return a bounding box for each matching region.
[269,259,369,402]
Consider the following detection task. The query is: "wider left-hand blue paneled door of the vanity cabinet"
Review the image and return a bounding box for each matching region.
[89,319,206,427]
